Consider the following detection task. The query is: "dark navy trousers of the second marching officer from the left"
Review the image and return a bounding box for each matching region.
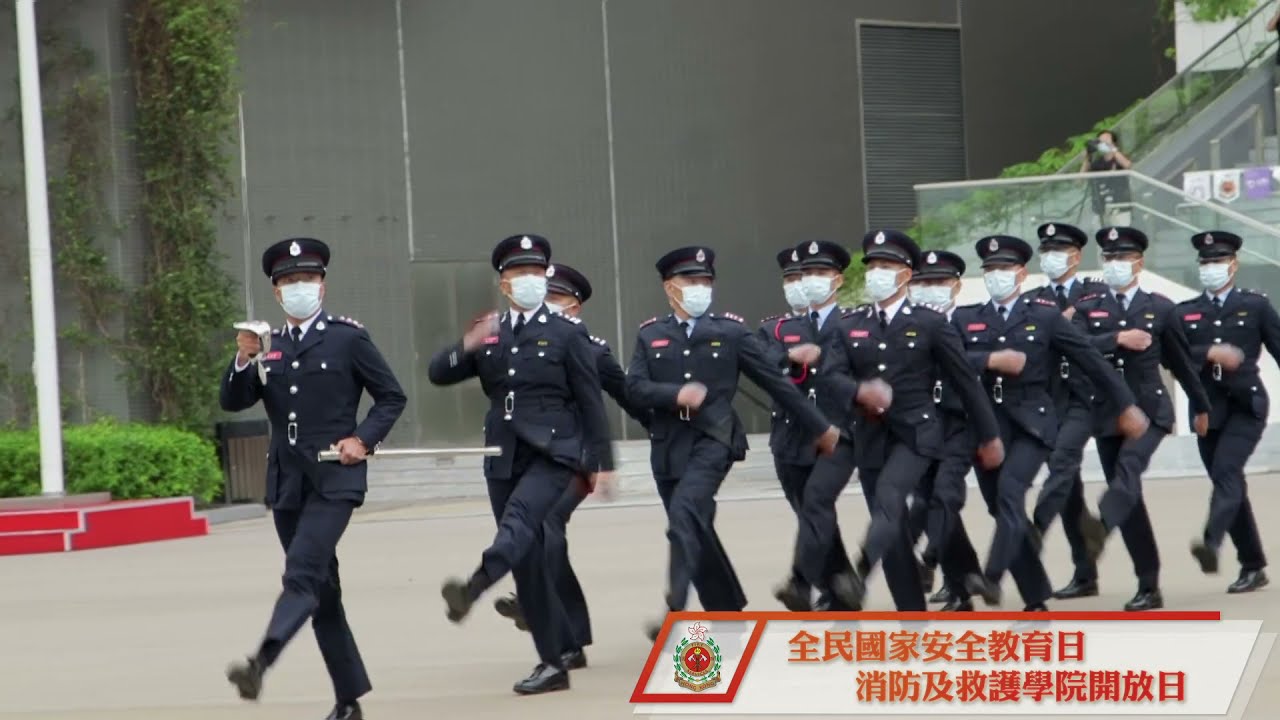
[472,443,573,667]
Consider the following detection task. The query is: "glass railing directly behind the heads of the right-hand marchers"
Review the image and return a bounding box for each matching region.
[915,170,1280,292]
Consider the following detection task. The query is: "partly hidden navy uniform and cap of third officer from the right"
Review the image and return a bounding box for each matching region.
[1028,223,1107,600]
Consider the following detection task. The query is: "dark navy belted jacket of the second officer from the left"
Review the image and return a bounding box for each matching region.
[428,306,613,480]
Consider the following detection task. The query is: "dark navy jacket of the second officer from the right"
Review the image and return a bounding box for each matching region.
[1071,284,1210,437]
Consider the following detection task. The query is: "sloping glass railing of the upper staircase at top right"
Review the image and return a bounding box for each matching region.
[1059,0,1280,173]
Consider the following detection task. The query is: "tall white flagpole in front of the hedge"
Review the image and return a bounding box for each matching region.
[14,0,63,496]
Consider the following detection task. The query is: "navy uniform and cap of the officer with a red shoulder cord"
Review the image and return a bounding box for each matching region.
[773,241,854,611]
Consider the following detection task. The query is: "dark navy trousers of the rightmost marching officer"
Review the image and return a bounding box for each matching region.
[1197,411,1267,570]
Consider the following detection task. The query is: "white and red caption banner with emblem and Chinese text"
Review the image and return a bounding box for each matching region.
[631,612,1270,716]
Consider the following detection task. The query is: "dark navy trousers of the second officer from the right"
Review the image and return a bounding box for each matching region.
[1094,425,1166,591]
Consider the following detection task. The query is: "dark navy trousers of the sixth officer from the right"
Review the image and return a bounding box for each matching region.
[858,442,933,611]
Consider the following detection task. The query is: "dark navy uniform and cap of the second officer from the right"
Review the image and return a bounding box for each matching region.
[1071,227,1210,610]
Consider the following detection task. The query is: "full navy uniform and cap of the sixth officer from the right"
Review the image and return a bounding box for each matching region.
[820,231,998,611]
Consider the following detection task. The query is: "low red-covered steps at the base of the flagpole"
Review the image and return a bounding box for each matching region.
[0,493,209,555]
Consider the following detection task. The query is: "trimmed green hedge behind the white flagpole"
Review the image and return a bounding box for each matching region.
[0,420,223,502]
